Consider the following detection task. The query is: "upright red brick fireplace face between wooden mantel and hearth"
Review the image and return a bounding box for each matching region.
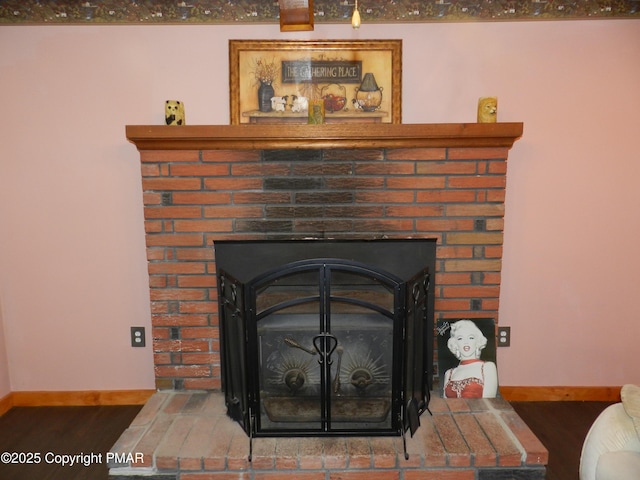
[141,148,508,389]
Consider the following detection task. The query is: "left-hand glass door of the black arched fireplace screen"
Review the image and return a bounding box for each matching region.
[253,268,322,433]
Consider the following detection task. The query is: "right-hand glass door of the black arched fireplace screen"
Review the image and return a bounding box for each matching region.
[327,269,401,432]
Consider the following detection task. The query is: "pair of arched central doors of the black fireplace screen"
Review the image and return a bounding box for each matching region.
[248,259,404,434]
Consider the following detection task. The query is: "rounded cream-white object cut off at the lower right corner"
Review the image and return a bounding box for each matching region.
[580,385,640,480]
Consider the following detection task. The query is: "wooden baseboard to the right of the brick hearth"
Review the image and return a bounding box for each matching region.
[500,386,621,402]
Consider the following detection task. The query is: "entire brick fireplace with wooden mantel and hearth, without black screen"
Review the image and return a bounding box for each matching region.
[111,123,546,479]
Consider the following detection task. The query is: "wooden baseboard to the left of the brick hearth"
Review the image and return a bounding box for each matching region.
[6,390,155,411]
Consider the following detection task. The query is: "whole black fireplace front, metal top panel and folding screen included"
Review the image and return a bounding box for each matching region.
[215,239,435,456]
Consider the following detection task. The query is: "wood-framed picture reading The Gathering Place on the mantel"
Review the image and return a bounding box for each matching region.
[229,40,402,125]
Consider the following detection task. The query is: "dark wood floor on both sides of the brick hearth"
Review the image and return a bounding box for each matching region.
[0,402,609,480]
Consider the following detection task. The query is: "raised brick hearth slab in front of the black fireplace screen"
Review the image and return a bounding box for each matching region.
[109,392,548,480]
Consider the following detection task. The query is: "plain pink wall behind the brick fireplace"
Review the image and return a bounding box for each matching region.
[0,20,640,396]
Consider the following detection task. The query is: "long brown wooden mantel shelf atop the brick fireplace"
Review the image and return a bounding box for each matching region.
[126,122,523,150]
